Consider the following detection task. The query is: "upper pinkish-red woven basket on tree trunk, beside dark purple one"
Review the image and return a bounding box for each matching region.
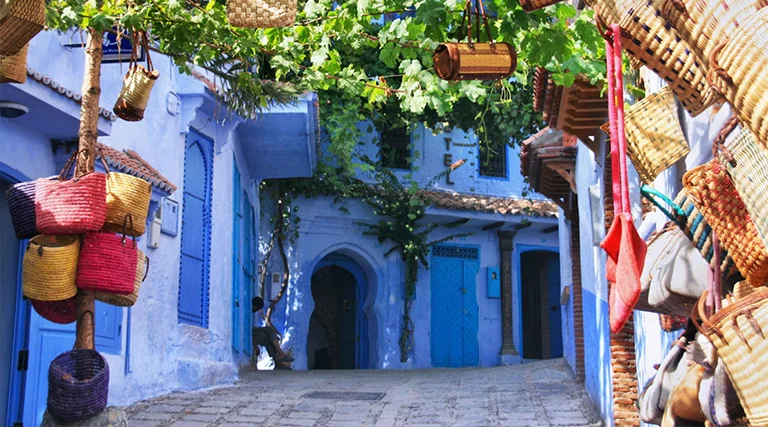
[35,151,107,236]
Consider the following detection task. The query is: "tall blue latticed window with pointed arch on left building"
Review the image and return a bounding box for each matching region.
[178,131,213,328]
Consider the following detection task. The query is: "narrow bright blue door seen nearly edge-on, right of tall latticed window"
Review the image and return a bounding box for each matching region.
[232,164,243,354]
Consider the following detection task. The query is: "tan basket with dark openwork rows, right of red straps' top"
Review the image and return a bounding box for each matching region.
[620,0,718,116]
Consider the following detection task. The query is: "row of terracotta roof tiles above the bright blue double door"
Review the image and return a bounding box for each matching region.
[421,190,557,218]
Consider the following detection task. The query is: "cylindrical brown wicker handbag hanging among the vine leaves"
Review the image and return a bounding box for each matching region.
[432,0,517,80]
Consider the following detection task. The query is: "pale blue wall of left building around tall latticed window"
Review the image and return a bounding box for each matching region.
[0,32,314,412]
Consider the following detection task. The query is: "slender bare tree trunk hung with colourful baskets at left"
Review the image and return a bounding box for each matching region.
[75,29,103,349]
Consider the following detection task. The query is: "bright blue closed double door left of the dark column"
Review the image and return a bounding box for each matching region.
[430,245,480,367]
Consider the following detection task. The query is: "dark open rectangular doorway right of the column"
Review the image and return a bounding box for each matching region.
[518,250,563,359]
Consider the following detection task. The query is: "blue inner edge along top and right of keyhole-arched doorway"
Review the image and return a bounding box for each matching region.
[312,254,370,369]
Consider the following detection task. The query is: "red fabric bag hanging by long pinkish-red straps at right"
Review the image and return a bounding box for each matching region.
[600,24,648,333]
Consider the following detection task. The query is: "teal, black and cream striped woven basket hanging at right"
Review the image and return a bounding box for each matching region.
[640,185,739,279]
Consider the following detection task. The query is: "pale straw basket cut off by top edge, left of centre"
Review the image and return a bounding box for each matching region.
[227,0,296,28]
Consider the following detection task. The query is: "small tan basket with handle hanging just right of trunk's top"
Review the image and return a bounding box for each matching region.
[112,31,160,122]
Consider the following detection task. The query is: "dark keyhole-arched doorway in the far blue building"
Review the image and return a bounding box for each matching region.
[307,253,369,369]
